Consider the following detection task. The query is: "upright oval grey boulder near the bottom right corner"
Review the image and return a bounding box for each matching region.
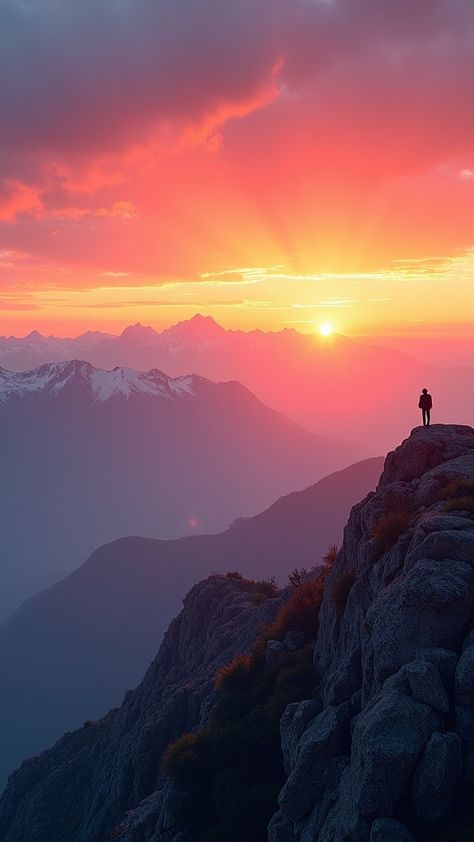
[411,732,462,822]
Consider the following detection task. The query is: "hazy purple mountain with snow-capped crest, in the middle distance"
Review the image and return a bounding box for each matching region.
[0,361,359,618]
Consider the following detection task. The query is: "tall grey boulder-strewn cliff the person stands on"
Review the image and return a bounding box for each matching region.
[269,426,474,842]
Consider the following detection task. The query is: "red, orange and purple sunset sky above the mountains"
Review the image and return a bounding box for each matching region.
[0,0,474,337]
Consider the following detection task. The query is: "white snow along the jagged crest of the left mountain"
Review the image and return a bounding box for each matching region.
[0,360,195,404]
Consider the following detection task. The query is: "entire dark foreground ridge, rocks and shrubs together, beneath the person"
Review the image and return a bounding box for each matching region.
[0,426,474,842]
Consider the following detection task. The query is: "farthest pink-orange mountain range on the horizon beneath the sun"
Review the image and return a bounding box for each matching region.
[0,315,474,454]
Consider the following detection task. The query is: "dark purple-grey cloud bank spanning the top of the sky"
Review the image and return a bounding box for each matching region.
[0,0,474,166]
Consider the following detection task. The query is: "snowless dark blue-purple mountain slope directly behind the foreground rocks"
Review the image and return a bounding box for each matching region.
[0,452,382,779]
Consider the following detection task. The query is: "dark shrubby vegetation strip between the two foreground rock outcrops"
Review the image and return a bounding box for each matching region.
[163,573,324,842]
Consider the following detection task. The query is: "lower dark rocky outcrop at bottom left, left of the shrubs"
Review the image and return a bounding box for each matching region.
[0,576,286,842]
